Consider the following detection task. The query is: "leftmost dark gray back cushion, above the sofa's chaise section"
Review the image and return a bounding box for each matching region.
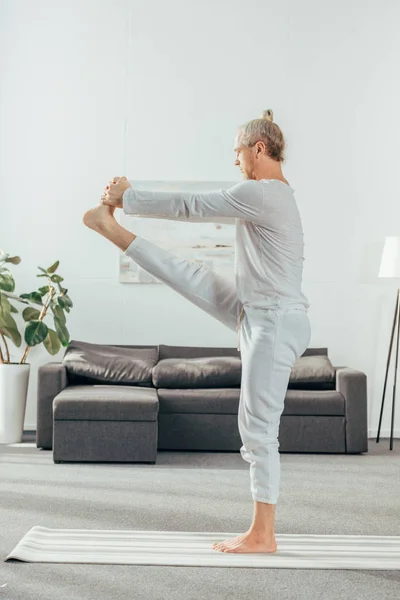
[62,340,158,387]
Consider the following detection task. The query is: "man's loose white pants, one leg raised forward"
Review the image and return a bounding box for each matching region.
[125,237,311,504]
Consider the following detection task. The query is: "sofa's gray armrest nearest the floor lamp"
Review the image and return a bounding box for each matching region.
[335,367,368,453]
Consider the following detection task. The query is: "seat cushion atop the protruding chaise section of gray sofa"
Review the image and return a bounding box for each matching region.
[53,385,158,421]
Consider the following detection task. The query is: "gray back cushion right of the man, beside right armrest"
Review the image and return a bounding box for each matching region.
[289,355,336,389]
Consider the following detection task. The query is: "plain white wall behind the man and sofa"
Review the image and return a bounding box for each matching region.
[0,0,400,436]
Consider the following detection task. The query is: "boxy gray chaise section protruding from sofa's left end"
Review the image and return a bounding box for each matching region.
[53,385,158,464]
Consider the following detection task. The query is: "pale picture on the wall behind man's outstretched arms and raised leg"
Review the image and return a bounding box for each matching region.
[119,180,237,283]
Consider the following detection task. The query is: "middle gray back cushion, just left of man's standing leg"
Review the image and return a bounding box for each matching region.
[153,356,242,389]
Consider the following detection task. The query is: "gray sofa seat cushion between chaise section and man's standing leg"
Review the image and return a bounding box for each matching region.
[157,388,240,415]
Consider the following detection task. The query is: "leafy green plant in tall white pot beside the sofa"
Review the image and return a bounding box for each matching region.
[0,251,73,444]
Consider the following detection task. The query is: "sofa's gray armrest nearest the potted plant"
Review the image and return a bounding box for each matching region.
[36,362,68,450]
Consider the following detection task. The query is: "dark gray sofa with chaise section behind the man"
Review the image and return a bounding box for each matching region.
[36,345,368,463]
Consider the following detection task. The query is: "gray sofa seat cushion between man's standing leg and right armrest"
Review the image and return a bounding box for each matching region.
[282,389,346,416]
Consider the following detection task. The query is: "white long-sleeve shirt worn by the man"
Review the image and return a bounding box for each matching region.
[123,179,309,309]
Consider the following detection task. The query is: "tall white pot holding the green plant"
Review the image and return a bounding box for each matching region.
[0,364,30,444]
